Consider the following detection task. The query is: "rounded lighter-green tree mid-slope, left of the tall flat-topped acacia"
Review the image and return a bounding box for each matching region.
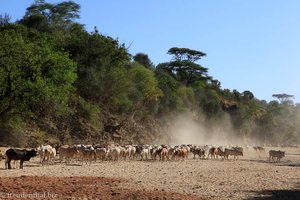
[110,63,161,113]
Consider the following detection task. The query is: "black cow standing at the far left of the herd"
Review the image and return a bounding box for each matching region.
[5,149,37,169]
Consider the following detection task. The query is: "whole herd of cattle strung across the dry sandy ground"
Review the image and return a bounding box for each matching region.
[1,144,285,169]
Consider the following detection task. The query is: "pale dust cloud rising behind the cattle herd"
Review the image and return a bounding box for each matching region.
[162,113,246,146]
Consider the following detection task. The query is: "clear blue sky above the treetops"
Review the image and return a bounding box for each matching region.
[0,0,300,103]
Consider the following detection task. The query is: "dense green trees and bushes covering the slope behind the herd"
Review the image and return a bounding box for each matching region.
[0,0,300,146]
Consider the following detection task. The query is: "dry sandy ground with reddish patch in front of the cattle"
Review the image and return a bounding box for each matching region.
[0,148,300,199]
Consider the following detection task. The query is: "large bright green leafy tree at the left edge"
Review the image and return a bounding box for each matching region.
[0,26,76,117]
